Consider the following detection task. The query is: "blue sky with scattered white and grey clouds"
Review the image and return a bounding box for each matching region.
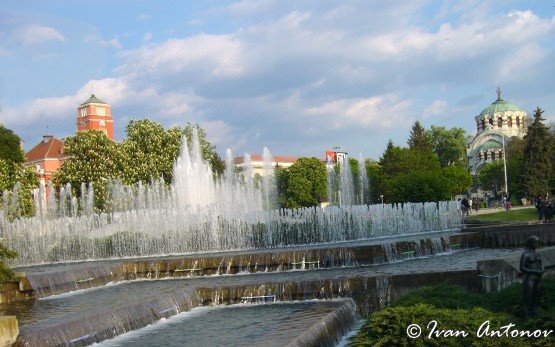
[0,0,555,159]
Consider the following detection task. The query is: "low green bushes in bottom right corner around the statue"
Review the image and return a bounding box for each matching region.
[350,278,555,346]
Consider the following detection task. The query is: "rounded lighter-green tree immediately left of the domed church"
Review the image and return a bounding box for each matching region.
[426,125,467,167]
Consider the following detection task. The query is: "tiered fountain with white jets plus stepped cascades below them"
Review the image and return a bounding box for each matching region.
[0,134,468,345]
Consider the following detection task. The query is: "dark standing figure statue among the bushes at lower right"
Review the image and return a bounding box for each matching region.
[520,236,545,318]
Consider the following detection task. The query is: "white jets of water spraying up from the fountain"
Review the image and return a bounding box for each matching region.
[0,133,460,265]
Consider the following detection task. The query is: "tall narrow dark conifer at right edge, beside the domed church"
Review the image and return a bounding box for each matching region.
[521,107,553,199]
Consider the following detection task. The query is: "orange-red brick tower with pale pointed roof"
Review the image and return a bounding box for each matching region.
[77,94,114,140]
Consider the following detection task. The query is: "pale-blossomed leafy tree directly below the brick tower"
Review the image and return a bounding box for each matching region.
[54,130,124,210]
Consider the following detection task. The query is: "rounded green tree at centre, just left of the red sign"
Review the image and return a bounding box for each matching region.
[277,158,327,208]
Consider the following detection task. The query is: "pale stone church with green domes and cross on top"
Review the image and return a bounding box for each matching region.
[467,88,527,175]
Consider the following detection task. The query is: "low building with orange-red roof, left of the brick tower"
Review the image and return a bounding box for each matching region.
[25,135,64,192]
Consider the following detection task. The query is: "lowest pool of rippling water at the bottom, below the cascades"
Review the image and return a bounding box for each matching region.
[97,301,356,347]
